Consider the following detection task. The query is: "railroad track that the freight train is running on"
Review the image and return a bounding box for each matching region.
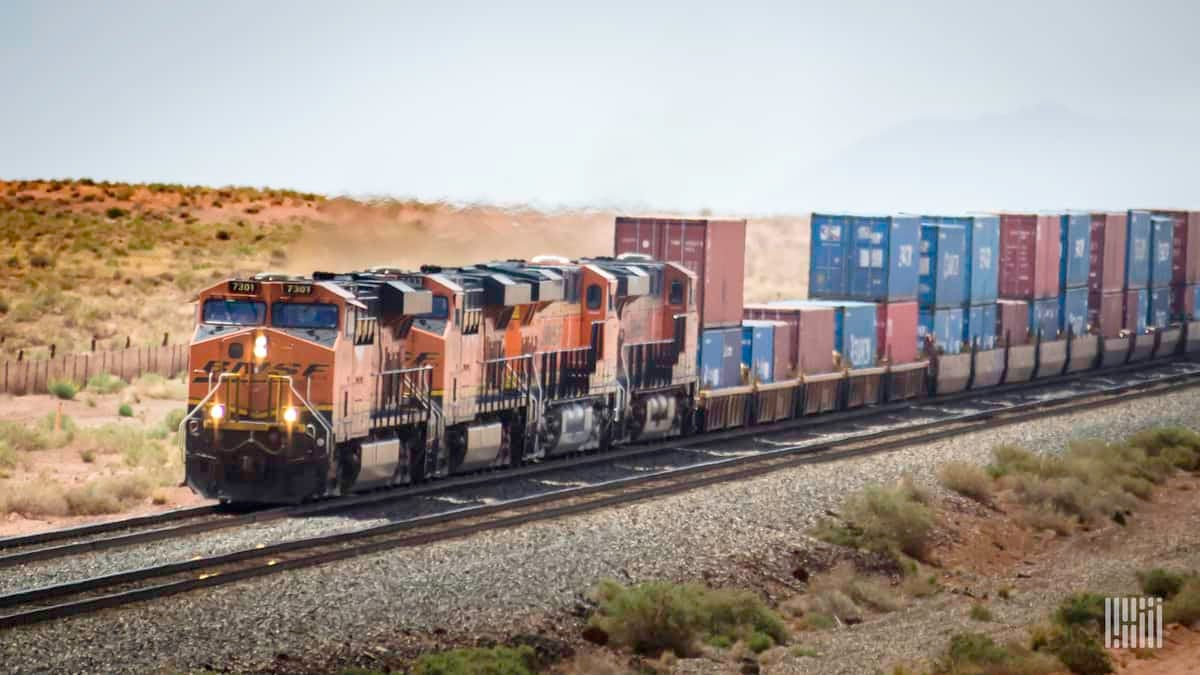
[0,358,1186,569]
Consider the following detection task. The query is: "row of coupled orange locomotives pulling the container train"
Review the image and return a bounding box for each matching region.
[181,256,698,502]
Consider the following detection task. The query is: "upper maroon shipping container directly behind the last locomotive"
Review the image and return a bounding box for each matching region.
[614,216,746,328]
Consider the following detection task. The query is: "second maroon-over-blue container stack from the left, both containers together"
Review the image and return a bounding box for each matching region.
[1000,214,1060,340]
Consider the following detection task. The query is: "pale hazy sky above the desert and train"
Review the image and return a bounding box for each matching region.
[0,0,1200,213]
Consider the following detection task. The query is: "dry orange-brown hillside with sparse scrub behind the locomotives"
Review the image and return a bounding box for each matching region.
[0,179,808,358]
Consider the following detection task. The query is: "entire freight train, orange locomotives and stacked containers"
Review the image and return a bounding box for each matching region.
[180,214,1200,503]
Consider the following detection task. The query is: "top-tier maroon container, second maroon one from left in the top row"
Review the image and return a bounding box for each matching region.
[1000,214,1062,300]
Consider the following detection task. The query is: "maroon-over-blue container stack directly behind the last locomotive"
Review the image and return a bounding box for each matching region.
[613,216,746,388]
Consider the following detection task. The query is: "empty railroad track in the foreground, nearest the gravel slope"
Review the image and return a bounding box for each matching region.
[0,366,1200,628]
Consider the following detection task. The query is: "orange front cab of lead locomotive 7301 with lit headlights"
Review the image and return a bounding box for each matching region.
[180,276,348,502]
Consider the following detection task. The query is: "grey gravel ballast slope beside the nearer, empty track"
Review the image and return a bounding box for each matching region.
[0,381,1200,673]
